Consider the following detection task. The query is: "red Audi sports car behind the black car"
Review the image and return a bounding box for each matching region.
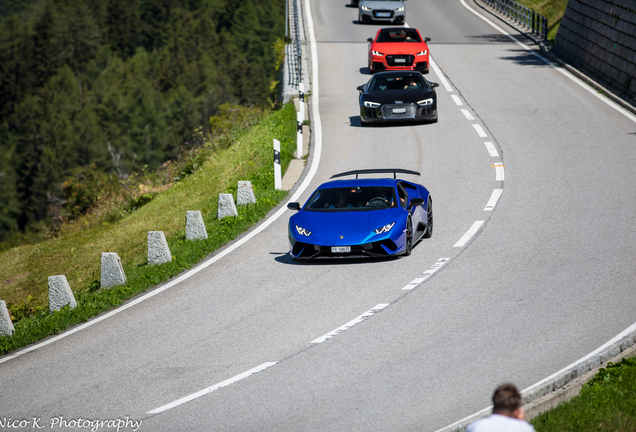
[367,27,431,74]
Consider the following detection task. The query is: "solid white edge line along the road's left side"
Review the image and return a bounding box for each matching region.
[0,0,322,363]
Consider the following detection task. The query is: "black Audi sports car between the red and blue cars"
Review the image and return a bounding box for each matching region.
[358,71,439,126]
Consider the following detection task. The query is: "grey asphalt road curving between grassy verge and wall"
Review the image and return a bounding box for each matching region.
[0,0,636,432]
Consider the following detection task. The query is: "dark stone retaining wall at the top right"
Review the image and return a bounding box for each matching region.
[553,0,636,105]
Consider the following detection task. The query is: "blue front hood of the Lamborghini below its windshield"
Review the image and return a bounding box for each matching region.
[295,209,398,235]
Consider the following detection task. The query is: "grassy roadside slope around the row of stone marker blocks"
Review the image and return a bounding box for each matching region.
[0,104,296,354]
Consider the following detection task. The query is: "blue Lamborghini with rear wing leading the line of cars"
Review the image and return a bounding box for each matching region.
[287,169,433,259]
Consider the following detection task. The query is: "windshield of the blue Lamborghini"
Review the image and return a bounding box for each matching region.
[305,186,397,212]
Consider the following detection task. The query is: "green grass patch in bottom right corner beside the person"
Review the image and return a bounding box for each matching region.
[531,358,636,432]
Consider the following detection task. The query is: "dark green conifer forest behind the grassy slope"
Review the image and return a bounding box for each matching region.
[0,0,285,243]
